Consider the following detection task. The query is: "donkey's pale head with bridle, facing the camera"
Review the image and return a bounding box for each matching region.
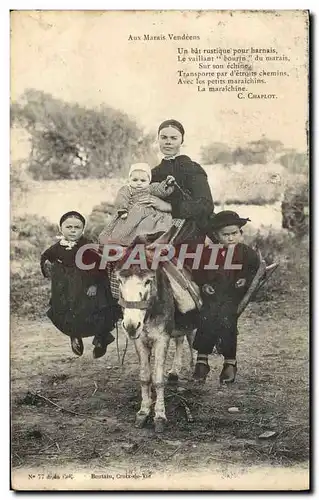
[116,265,157,339]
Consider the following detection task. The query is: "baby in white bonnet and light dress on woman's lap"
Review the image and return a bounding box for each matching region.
[99,163,174,246]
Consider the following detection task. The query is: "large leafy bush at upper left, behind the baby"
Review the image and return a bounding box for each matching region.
[11,89,155,180]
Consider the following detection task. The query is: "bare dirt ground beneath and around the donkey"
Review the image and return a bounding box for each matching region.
[11,298,309,489]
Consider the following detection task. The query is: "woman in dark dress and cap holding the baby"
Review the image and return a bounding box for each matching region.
[152,120,214,242]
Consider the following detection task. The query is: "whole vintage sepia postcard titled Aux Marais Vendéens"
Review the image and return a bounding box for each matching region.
[10,10,310,491]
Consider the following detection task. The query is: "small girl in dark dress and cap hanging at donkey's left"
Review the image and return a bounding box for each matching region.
[41,211,118,358]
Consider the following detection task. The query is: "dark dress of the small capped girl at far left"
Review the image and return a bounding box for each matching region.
[41,237,118,338]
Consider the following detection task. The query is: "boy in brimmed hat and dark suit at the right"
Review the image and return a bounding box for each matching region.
[193,210,259,383]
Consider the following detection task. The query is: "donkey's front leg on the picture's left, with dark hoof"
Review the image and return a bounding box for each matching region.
[134,338,152,427]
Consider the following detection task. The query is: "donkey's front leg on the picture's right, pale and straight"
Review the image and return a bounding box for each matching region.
[153,332,169,432]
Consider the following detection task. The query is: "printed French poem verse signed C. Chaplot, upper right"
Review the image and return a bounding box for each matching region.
[177,47,290,99]
